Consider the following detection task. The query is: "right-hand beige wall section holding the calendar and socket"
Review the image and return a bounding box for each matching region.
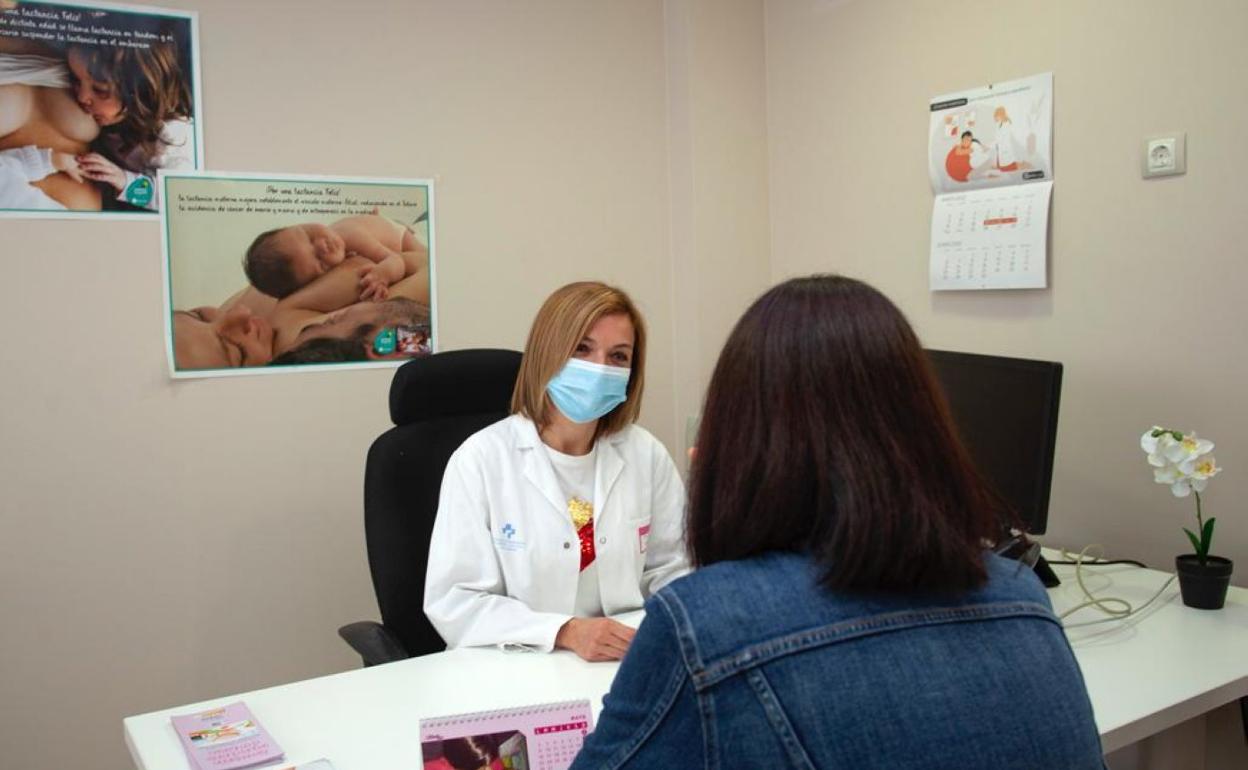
[766,0,1248,576]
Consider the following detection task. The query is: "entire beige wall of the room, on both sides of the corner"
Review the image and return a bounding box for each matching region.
[7,0,1248,769]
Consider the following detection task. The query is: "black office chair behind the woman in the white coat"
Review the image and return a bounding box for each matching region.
[338,349,520,666]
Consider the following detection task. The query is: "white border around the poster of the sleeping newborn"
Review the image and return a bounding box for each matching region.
[156,168,442,379]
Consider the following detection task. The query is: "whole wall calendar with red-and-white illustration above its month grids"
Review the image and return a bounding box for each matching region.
[927,72,1053,291]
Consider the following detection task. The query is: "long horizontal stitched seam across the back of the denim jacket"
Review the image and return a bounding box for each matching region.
[690,602,1061,690]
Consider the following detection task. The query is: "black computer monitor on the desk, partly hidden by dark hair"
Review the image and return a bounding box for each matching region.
[927,351,1062,534]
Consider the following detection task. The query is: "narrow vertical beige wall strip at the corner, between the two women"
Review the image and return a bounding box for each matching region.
[665,0,770,461]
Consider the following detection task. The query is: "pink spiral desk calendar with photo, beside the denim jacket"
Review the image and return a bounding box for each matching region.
[421,700,594,770]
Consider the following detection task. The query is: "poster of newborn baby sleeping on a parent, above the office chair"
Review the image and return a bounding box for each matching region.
[157,171,437,378]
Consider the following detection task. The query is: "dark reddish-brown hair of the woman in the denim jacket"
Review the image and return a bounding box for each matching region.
[686,276,1001,590]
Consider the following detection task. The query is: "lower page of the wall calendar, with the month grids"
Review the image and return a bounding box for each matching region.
[930,182,1053,291]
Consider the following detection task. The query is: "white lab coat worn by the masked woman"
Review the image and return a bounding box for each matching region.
[424,414,688,651]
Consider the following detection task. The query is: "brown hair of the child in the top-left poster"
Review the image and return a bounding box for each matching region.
[70,42,191,163]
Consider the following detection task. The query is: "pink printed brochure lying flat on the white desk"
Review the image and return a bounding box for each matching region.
[172,701,282,770]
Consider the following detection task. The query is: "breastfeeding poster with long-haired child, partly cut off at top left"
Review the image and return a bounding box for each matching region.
[0,0,203,220]
